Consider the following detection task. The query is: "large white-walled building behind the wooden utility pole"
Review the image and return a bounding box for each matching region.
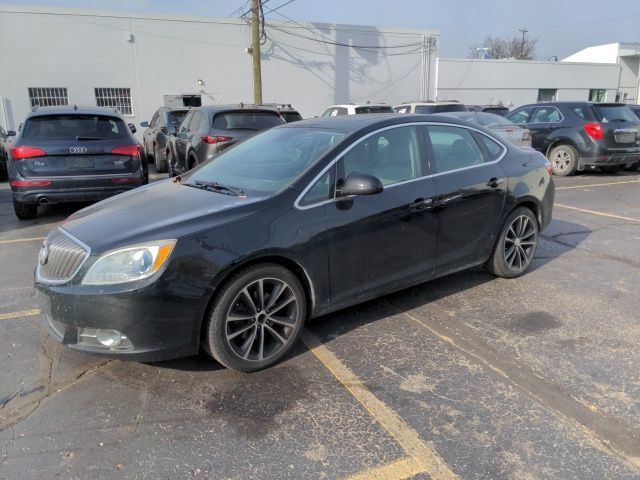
[0,6,437,134]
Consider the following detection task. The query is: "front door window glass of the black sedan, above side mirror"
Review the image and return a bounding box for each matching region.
[339,126,422,185]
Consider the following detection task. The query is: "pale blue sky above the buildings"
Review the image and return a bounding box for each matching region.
[5,0,640,60]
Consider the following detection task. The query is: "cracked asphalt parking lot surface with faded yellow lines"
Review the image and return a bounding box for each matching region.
[0,172,640,480]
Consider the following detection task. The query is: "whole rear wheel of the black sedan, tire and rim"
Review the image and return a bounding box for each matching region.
[487,207,540,278]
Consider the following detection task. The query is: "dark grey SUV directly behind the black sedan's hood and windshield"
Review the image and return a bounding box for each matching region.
[166,104,285,177]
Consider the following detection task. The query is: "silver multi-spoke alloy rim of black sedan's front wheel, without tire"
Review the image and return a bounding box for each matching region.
[224,278,301,362]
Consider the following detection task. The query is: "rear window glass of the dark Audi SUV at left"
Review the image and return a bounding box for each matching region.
[22,114,129,140]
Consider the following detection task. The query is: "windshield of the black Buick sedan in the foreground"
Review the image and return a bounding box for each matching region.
[183,128,345,195]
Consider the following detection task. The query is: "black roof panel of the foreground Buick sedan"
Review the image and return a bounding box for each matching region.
[276,113,478,134]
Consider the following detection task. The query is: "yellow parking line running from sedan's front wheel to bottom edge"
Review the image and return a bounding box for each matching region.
[302,330,458,480]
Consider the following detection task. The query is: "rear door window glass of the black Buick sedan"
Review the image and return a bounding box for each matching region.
[428,125,484,173]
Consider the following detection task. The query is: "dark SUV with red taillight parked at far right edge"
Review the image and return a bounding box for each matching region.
[507,102,640,176]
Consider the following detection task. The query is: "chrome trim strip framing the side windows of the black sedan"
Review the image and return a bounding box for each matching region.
[293,122,509,210]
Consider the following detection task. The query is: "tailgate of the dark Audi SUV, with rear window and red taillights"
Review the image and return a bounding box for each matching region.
[13,114,140,178]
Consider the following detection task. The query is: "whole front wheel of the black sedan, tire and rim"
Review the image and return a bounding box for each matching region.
[204,263,306,372]
